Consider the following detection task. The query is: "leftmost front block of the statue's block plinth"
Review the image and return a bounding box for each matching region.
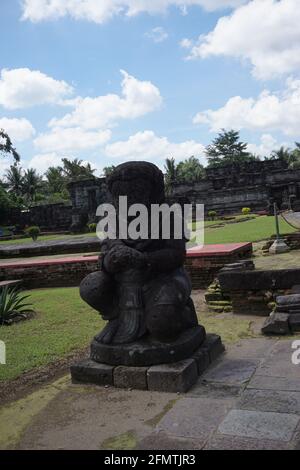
[71,359,114,385]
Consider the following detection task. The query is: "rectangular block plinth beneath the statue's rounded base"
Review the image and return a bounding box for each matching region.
[71,334,224,392]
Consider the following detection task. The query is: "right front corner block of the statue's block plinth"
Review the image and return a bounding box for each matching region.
[147,359,198,392]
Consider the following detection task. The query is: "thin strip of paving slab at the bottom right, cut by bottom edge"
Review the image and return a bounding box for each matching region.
[204,434,293,450]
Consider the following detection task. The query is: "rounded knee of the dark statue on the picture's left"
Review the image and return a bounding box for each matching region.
[80,271,113,314]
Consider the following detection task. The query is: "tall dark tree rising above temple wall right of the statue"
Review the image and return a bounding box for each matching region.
[205,129,252,166]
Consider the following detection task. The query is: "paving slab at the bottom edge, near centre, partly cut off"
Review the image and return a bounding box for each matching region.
[135,432,206,450]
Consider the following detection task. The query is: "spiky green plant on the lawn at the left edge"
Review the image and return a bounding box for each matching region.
[0,286,33,325]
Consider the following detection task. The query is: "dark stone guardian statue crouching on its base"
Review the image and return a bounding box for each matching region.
[80,162,205,364]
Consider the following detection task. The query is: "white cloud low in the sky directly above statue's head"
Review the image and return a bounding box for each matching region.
[105,130,205,162]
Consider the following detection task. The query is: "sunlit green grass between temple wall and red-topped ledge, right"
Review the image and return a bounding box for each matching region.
[204,216,296,244]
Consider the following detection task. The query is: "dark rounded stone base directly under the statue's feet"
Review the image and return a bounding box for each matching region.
[91,325,206,367]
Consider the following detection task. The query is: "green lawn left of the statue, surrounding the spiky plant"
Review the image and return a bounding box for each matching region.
[0,287,104,381]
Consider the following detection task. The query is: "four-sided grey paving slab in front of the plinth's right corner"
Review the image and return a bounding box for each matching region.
[157,397,232,440]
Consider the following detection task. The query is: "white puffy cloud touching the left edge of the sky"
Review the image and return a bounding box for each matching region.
[0,68,73,109]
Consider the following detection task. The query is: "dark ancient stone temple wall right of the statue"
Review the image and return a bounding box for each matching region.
[172,160,300,215]
